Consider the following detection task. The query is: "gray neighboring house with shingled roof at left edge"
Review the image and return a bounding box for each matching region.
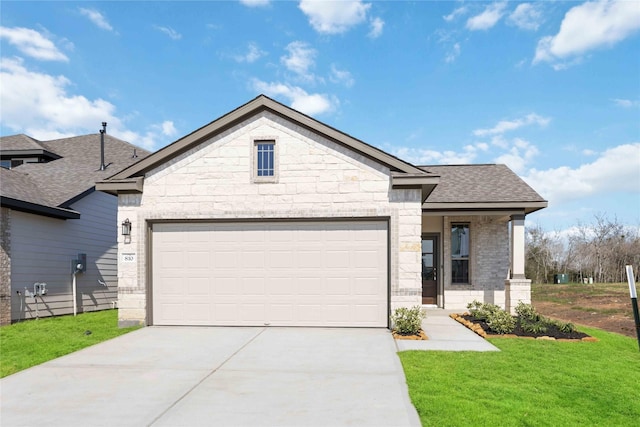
[0,134,149,324]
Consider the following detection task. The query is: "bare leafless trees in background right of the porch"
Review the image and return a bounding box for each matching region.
[525,214,640,283]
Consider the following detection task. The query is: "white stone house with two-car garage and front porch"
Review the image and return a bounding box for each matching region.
[97,95,547,327]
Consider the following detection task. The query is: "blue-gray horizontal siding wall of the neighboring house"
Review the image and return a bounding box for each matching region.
[11,192,118,320]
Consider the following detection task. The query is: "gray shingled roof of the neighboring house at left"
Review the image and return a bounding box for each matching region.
[0,134,150,221]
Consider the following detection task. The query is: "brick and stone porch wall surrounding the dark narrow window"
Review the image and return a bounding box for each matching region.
[443,216,509,310]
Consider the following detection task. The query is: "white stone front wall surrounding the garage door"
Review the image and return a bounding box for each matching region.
[118,112,422,326]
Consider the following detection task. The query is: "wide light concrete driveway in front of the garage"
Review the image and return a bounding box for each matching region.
[0,327,420,426]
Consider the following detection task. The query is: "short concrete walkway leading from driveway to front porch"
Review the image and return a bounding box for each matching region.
[396,309,500,351]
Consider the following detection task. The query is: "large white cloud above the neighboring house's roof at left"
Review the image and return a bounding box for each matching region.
[0,58,170,150]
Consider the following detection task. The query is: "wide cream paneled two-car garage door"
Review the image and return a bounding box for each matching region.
[152,221,388,327]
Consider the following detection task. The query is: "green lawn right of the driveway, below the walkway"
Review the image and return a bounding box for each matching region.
[399,327,640,426]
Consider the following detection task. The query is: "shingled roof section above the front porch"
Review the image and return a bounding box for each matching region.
[420,165,547,213]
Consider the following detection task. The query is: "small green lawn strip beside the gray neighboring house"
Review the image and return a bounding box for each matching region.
[0,310,137,378]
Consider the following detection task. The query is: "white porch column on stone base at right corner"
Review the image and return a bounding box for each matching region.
[504,214,531,314]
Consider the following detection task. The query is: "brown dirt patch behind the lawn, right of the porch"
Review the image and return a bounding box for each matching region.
[531,283,636,337]
